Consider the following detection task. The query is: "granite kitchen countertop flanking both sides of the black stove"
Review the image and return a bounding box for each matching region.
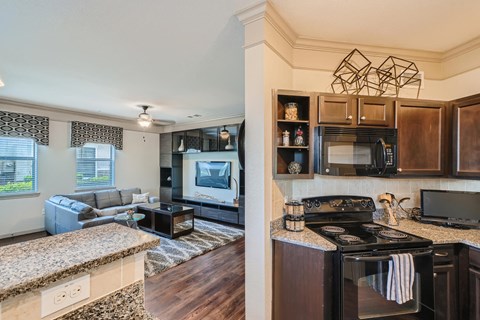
[271,220,480,251]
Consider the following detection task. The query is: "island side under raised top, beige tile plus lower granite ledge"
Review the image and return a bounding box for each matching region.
[0,246,153,320]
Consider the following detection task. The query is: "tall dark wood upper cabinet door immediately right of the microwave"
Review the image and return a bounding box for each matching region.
[396,100,447,176]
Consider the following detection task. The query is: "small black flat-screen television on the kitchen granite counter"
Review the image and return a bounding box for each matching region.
[420,189,480,227]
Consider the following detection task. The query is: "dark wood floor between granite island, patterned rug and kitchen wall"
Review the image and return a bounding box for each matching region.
[145,238,245,320]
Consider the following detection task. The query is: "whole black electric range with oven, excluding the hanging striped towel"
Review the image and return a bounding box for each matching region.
[302,196,435,320]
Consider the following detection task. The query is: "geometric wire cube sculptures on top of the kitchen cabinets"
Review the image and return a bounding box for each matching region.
[331,49,422,98]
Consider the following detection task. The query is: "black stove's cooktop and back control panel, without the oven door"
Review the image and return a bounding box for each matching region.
[302,196,432,252]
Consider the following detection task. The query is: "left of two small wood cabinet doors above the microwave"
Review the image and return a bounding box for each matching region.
[318,95,356,125]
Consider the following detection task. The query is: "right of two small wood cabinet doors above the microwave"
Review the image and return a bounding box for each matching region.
[357,97,395,128]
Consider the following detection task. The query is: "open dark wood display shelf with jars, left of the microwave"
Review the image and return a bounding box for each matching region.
[273,90,315,179]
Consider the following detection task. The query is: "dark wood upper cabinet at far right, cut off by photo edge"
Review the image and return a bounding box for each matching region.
[452,96,480,178]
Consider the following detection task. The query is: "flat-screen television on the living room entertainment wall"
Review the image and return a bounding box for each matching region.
[195,161,232,189]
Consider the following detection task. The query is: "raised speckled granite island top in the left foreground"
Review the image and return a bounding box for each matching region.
[0,223,160,302]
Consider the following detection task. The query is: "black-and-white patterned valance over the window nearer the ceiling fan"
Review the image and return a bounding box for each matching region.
[70,121,123,150]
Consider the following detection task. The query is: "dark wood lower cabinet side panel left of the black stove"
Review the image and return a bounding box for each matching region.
[273,241,333,320]
